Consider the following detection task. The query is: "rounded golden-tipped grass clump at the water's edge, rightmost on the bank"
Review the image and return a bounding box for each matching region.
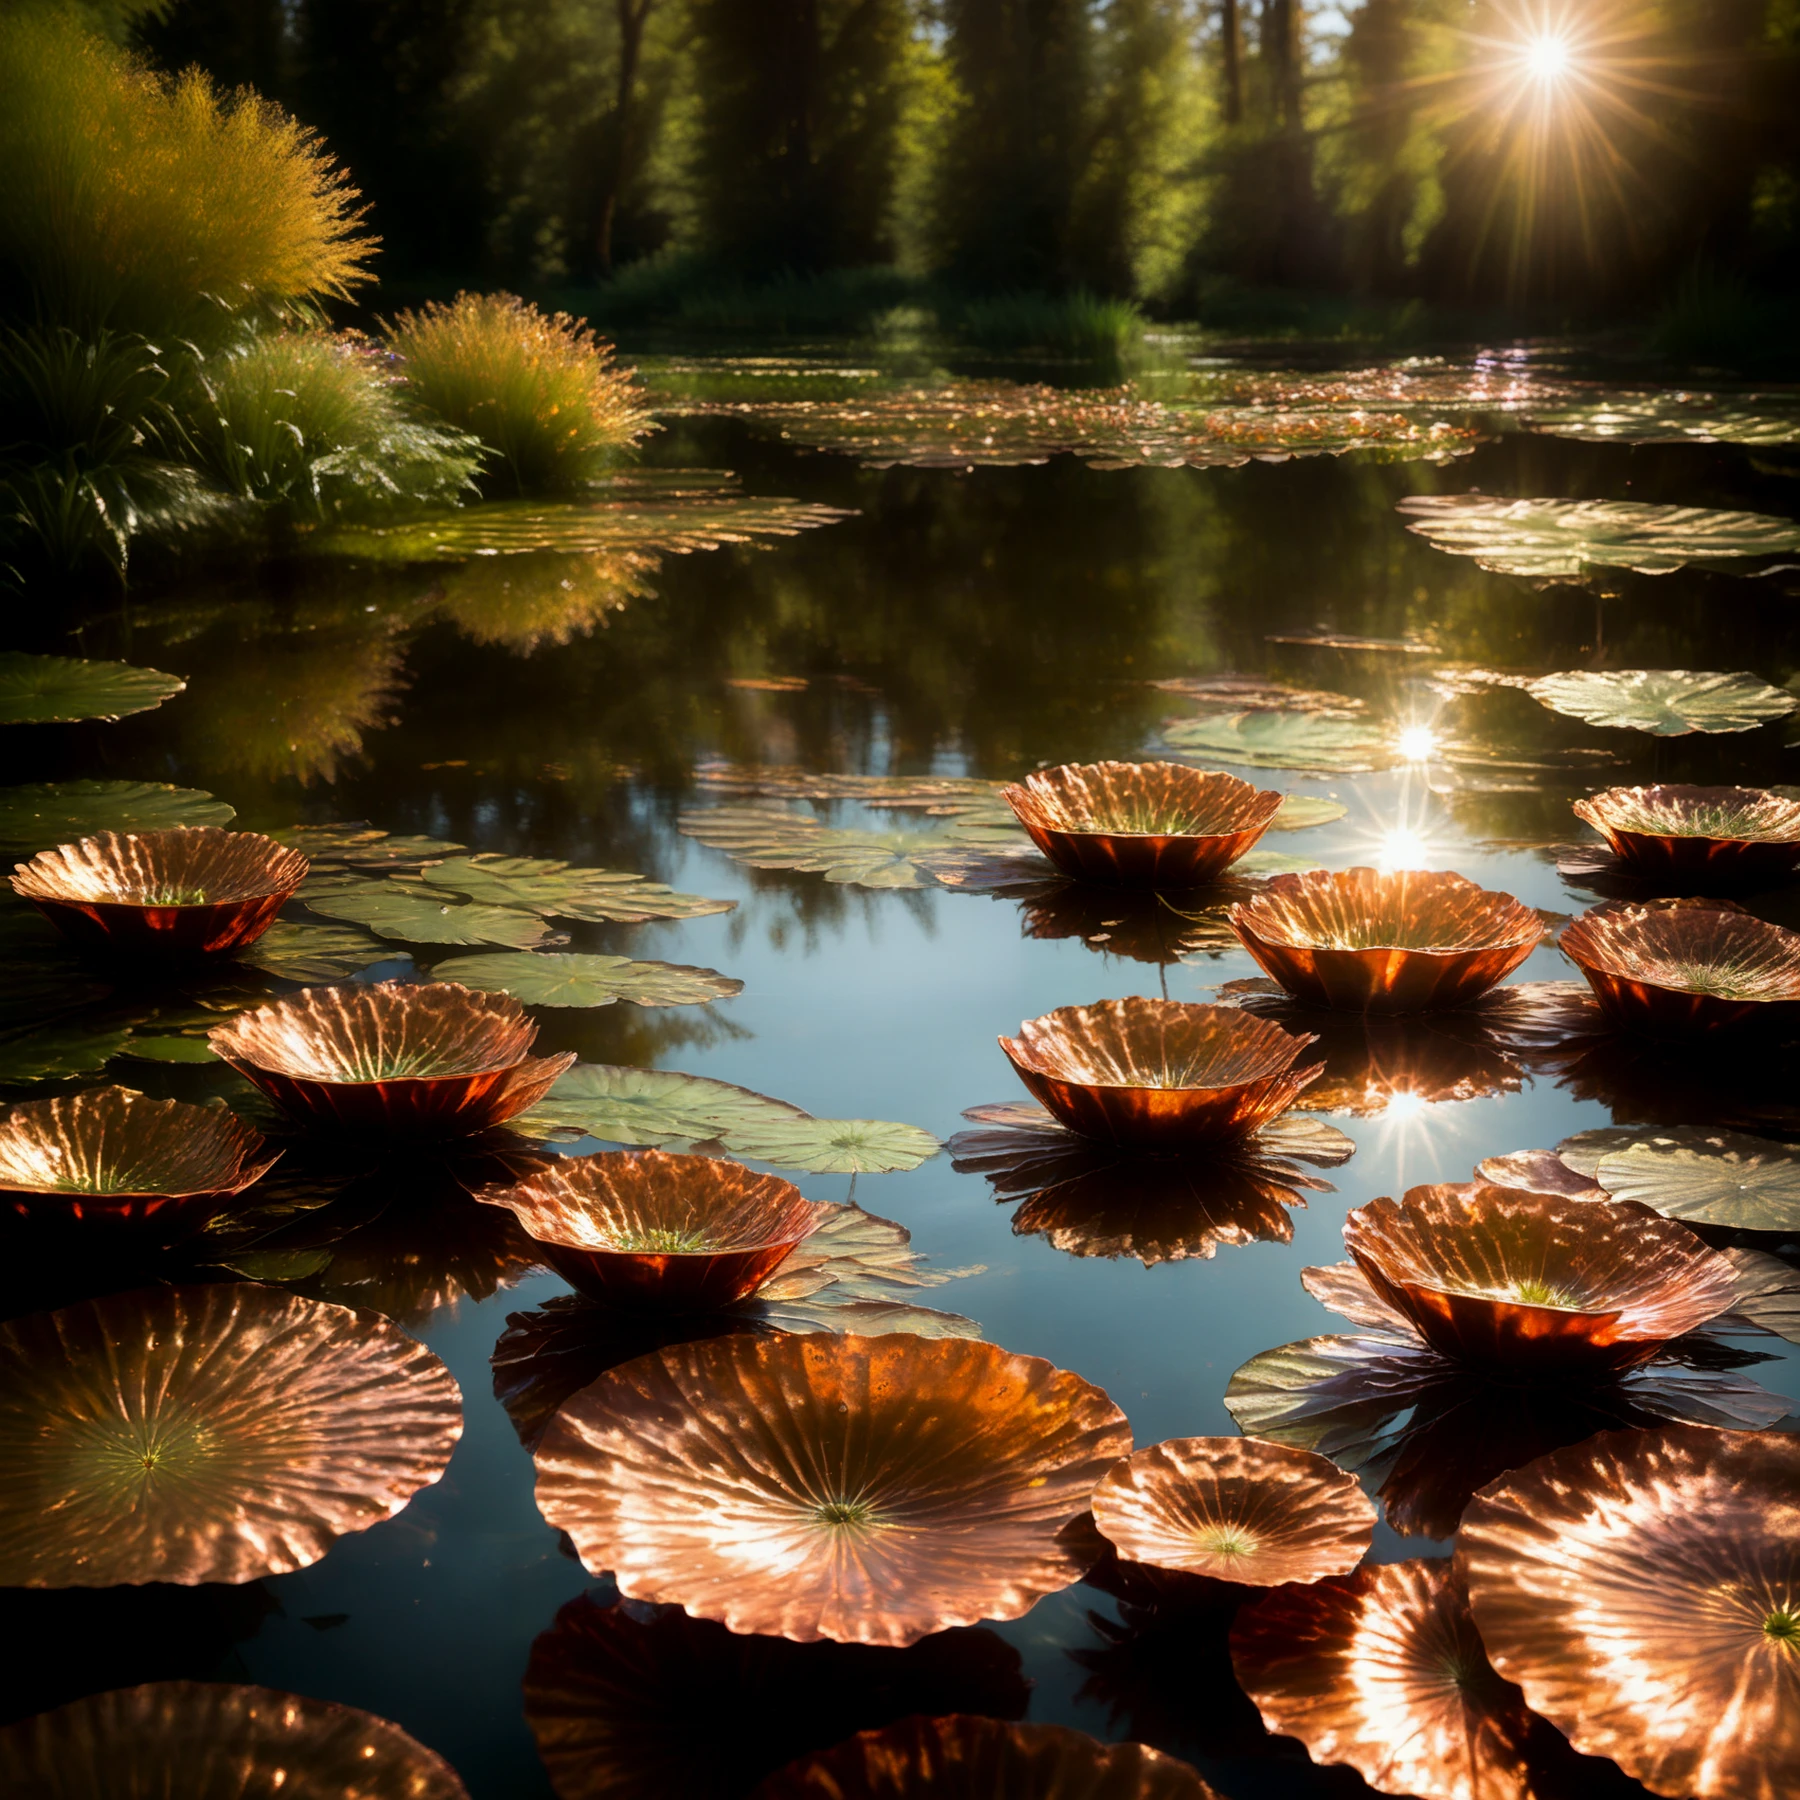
[387,293,652,495]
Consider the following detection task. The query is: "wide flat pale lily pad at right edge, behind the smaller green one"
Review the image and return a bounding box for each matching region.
[1399,493,1800,581]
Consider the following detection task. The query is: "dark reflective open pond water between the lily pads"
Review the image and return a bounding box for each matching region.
[0,343,1800,1800]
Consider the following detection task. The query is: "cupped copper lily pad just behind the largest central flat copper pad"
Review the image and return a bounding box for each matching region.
[475,1150,837,1312]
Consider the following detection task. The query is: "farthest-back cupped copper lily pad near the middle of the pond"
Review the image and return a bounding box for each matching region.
[1001,763,1282,887]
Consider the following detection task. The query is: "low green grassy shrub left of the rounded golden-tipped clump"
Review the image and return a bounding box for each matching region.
[189,331,482,518]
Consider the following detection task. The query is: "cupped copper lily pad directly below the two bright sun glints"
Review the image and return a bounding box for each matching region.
[1231,869,1548,1013]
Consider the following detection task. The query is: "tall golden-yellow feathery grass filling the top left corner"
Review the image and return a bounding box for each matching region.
[0,5,374,338]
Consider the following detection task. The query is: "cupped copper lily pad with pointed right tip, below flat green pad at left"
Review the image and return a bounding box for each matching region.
[207,981,576,1136]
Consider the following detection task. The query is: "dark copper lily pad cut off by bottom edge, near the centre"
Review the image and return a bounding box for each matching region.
[752,1714,1219,1800]
